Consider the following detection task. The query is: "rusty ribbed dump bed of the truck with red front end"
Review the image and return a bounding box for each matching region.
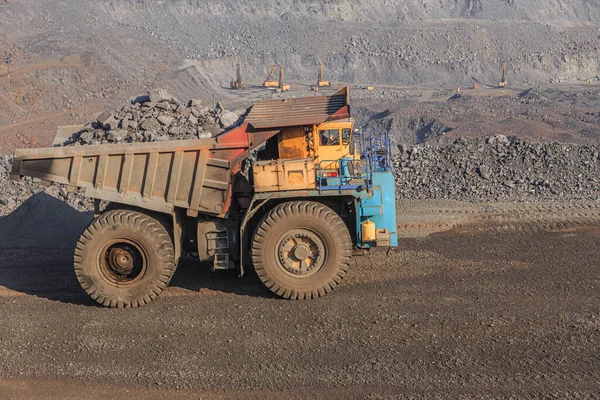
[11,125,248,215]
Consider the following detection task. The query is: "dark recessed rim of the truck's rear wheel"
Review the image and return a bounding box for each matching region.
[98,239,148,287]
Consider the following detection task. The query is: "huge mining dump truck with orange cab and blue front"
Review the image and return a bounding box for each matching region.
[12,88,398,308]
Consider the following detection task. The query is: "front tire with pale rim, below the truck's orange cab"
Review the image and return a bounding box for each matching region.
[252,201,352,300]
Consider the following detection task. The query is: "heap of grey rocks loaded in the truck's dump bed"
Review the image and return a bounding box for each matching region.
[59,89,240,146]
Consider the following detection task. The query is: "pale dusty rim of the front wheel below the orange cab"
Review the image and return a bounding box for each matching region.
[276,229,326,278]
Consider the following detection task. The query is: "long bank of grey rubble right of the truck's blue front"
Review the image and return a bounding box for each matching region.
[394,135,600,202]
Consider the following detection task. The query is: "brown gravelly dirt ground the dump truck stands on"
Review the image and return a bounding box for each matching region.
[0,203,600,399]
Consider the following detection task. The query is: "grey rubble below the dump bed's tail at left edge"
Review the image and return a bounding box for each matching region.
[0,156,94,216]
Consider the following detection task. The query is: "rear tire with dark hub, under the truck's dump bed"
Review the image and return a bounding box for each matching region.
[74,210,176,308]
